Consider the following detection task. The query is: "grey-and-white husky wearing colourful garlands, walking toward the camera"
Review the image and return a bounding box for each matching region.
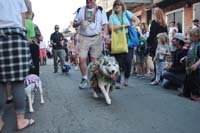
[87,56,119,104]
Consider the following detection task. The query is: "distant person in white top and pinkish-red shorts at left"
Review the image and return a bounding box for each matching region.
[39,36,47,65]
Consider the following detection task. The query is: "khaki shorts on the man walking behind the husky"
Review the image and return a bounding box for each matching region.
[78,35,103,58]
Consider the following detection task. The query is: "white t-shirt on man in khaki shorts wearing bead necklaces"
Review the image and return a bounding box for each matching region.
[74,6,108,36]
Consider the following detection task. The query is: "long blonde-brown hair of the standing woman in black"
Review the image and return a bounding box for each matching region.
[154,7,167,27]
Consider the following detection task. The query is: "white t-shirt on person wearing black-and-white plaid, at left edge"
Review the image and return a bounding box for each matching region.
[0,0,27,28]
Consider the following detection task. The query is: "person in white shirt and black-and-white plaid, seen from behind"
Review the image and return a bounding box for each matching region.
[0,0,35,132]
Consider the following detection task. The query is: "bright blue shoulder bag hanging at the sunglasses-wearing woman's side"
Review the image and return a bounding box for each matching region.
[126,13,139,48]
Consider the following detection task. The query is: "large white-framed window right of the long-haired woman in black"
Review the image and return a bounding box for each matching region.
[166,8,184,32]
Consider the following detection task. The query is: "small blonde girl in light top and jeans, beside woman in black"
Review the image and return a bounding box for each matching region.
[150,33,170,85]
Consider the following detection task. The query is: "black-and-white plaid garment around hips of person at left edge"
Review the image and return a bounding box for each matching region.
[0,28,30,82]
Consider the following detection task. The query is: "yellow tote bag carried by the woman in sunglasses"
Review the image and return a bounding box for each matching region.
[111,26,128,54]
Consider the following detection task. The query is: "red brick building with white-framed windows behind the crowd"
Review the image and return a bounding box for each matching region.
[97,0,200,32]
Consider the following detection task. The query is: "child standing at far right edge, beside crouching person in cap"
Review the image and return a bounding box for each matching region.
[179,28,200,101]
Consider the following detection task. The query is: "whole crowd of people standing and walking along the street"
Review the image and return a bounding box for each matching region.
[0,0,200,132]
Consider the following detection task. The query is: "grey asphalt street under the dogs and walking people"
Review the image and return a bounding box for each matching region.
[3,60,200,133]
